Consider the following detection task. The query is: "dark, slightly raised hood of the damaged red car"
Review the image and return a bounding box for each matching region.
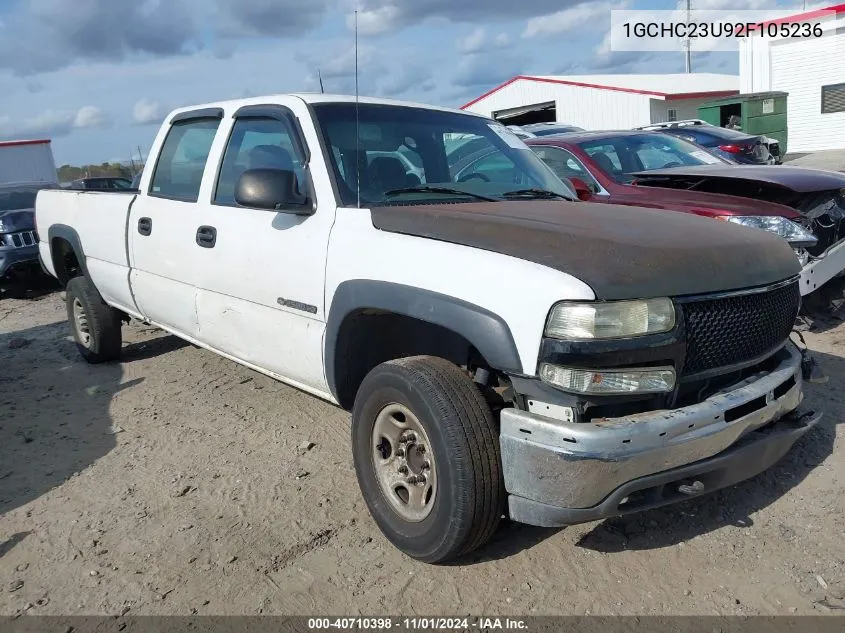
[633,164,845,193]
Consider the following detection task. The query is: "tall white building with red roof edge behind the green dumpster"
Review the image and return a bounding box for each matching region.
[739,4,845,152]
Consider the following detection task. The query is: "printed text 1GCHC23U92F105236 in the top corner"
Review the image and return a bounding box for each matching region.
[622,22,824,39]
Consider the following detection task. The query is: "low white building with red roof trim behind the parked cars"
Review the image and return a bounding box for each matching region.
[463,73,739,130]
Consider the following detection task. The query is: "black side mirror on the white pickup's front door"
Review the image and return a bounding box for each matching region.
[235,168,314,215]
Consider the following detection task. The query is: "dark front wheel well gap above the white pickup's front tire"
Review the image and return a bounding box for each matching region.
[334,309,489,409]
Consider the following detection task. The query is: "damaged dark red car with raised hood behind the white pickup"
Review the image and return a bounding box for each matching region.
[526,131,845,295]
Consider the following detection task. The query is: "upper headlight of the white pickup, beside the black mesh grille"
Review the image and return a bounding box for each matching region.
[546,298,675,340]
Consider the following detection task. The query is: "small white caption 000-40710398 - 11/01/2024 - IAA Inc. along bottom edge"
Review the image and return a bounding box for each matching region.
[308,617,526,631]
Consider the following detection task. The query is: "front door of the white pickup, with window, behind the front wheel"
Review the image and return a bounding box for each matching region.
[194,98,336,394]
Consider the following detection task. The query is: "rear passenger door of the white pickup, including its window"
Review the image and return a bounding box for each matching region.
[129,109,223,338]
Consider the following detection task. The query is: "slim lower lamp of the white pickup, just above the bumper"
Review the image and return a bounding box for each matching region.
[540,363,675,395]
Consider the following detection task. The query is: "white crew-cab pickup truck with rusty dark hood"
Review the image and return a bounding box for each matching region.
[36,94,821,562]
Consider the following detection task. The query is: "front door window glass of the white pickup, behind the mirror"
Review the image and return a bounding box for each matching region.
[214,117,305,205]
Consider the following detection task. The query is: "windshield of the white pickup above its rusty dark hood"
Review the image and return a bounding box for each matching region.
[313,103,575,206]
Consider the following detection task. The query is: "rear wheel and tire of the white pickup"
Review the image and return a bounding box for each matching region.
[65,277,123,363]
